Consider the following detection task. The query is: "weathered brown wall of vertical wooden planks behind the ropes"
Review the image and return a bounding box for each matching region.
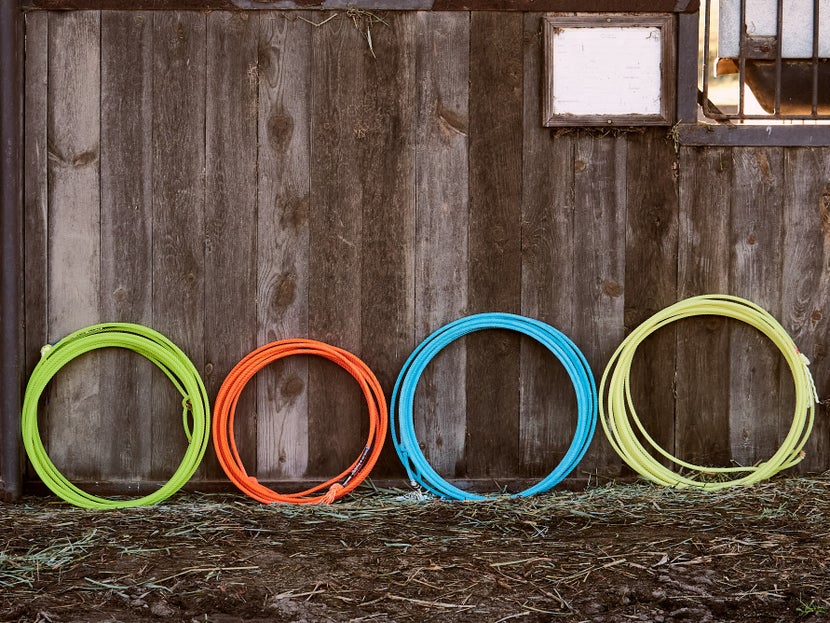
[25,12,830,488]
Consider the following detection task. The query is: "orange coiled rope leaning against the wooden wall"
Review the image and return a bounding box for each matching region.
[213,339,389,504]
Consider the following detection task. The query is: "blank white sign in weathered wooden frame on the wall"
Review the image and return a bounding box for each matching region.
[543,13,675,126]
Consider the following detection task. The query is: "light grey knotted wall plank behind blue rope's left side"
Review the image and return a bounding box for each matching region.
[413,13,470,477]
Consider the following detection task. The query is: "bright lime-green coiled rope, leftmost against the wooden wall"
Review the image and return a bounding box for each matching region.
[21,322,210,509]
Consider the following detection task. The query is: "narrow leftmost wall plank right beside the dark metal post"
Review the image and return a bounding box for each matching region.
[23,13,49,480]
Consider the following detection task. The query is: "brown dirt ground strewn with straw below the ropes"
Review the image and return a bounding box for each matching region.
[0,474,830,623]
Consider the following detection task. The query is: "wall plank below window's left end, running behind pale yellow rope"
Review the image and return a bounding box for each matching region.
[673,147,732,467]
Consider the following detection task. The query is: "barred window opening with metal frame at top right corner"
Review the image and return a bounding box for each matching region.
[677,0,830,145]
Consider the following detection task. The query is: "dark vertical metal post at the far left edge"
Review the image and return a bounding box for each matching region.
[0,0,23,502]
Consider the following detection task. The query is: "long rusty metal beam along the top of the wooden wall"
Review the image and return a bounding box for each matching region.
[23,0,700,13]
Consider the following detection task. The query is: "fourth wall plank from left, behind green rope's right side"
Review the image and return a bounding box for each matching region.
[151,12,205,480]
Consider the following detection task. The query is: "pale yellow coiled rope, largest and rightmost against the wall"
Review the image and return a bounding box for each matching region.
[600,294,818,490]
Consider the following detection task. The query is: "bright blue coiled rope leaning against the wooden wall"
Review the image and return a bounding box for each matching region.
[391,312,597,500]
